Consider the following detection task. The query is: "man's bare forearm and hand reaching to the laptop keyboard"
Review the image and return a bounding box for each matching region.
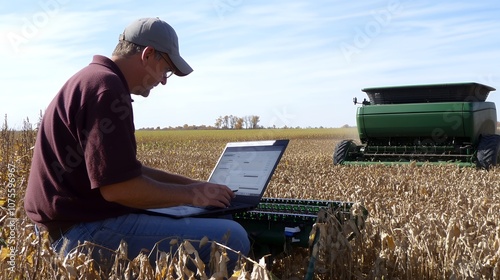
[99,175,234,209]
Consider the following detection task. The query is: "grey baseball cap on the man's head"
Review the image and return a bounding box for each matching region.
[120,18,193,76]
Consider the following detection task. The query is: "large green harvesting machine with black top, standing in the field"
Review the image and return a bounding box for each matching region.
[333,83,500,169]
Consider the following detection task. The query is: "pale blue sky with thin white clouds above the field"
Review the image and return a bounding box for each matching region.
[0,0,500,128]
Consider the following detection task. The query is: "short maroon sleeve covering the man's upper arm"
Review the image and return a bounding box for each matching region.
[77,90,141,189]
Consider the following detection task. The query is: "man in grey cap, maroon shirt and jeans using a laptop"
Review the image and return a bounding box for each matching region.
[25,18,249,272]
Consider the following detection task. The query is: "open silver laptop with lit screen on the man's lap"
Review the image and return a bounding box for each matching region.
[147,140,289,218]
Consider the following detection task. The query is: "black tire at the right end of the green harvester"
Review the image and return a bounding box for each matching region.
[477,134,500,170]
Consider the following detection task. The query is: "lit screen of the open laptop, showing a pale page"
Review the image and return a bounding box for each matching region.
[208,141,286,196]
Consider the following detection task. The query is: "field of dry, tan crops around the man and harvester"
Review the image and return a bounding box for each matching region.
[0,117,500,279]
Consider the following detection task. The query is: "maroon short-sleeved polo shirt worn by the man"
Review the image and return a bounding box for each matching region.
[24,56,141,230]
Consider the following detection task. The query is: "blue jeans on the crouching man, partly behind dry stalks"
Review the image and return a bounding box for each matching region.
[52,214,250,276]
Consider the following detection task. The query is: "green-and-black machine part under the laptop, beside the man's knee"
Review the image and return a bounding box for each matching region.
[233,198,368,280]
